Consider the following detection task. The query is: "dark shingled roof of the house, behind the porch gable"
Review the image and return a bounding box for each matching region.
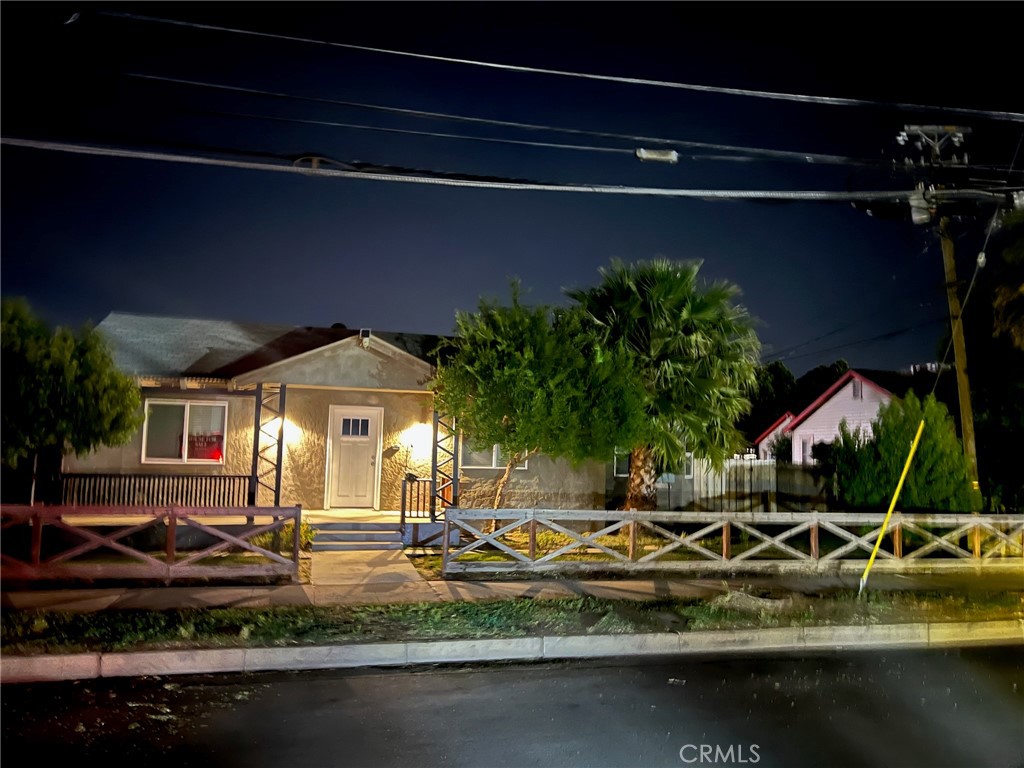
[97,312,442,379]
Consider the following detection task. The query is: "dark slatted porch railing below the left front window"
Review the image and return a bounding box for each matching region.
[61,473,249,507]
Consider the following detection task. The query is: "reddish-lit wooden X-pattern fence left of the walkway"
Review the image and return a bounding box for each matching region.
[0,506,302,581]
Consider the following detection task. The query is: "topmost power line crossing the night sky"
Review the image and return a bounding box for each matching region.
[96,10,1024,123]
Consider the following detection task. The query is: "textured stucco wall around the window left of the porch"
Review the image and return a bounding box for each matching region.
[65,389,255,475]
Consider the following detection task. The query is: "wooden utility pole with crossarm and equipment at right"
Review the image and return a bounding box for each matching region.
[896,125,980,490]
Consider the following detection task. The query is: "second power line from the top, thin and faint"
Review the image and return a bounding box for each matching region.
[124,72,885,166]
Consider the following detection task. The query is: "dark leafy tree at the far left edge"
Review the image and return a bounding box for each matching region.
[0,299,141,501]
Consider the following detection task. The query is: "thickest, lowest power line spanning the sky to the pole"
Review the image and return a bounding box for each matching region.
[6,138,1005,203]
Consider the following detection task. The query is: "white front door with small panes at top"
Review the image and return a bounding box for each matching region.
[328,406,384,508]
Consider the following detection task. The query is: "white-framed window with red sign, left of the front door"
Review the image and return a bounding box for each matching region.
[142,400,227,464]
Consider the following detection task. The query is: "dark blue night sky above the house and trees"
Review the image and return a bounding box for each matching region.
[0,2,1024,374]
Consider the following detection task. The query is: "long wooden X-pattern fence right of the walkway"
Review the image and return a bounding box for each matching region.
[442,508,1024,583]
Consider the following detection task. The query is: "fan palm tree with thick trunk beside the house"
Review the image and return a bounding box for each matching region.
[566,259,760,510]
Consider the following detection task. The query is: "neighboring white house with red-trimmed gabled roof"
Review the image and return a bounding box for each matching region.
[756,370,935,464]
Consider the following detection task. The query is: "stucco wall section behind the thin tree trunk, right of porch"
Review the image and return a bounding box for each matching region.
[458,456,605,509]
